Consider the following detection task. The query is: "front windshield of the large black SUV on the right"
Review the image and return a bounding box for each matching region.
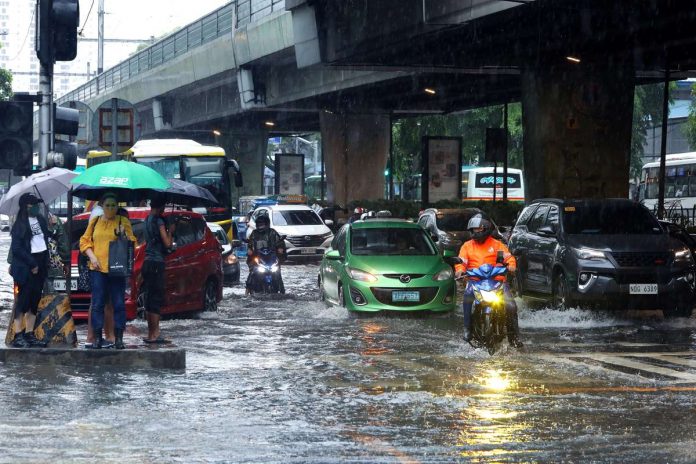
[563,203,662,235]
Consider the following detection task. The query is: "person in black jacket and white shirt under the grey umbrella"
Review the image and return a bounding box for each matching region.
[10,193,49,348]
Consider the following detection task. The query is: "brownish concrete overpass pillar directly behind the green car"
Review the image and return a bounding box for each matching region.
[319,112,391,206]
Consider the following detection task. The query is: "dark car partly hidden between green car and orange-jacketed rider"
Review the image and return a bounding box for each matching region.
[418,208,504,253]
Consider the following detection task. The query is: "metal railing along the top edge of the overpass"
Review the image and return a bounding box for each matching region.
[57,0,285,104]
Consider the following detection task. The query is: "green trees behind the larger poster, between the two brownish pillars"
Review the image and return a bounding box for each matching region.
[392,103,522,182]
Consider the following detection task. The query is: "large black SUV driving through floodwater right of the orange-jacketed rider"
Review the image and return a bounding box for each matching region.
[509,199,696,317]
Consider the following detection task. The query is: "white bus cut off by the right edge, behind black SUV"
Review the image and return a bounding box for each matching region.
[638,152,696,219]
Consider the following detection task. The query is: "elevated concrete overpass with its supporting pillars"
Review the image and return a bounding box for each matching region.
[60,0,696,203]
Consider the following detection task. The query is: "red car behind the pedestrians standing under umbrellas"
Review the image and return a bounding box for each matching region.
[62,208,223,320]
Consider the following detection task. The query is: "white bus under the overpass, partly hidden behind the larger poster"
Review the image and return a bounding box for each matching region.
[401,166,525,202]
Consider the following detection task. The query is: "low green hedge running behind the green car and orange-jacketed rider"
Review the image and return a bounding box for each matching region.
[347,200,524,225]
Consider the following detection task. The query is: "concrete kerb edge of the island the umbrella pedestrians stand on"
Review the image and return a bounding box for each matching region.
[0,345,186,369]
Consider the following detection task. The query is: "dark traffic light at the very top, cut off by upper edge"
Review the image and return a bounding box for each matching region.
[36,0,80,65]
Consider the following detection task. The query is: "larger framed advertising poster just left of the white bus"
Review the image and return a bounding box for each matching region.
[423,137,462,203]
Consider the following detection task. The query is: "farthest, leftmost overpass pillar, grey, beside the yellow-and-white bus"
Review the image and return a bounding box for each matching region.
[216,131,268,208]
